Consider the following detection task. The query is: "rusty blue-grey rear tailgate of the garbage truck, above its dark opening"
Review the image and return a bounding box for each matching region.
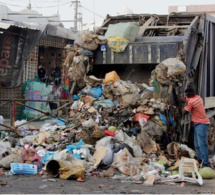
[94,13,204,78]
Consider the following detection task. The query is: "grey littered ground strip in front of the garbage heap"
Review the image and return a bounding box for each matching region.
[0,175,215,194]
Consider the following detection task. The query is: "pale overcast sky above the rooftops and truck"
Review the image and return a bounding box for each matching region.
[0,0,215,28]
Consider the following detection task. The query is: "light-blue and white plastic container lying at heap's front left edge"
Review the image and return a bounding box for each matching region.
[10,163,37,175]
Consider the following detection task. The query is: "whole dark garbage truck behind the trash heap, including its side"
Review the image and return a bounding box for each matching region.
[93,13,215,152]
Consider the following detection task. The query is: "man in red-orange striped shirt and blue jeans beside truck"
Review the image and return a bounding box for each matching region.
[184,87,210,167]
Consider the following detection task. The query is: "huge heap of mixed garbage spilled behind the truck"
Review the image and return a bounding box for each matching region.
[0,64,215,186]
